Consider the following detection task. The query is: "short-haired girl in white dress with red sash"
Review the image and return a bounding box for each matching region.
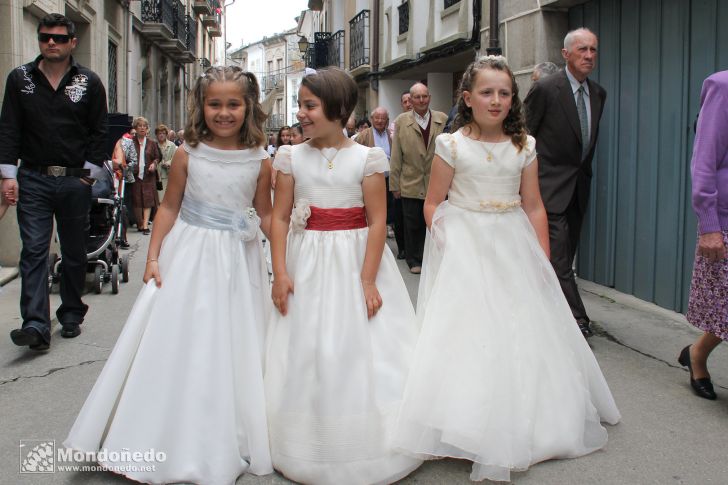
[265,68,420,485]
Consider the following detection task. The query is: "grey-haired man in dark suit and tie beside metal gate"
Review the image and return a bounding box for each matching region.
[524,28,607,337]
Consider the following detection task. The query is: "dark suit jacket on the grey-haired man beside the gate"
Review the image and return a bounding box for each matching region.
[524,70,607,214]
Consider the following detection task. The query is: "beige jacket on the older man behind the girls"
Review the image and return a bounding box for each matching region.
[389,110,447,199]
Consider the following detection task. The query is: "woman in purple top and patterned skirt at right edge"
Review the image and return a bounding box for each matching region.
[678,71,728,400]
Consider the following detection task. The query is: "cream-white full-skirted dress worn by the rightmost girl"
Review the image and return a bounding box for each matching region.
[395,131,620,481]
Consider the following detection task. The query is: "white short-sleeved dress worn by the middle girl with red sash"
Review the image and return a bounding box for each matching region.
[265,143,421,485]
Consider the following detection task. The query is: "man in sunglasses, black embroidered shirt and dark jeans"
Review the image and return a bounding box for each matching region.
[0,14,108,350]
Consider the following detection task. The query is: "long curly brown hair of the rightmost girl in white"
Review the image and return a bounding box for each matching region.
[451,56,526,152]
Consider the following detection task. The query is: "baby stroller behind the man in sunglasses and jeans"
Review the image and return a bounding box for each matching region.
[48,162,129,294]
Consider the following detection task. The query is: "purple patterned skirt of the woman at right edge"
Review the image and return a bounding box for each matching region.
[686,231,728,340]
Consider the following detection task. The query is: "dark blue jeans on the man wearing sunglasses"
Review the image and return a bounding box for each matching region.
[18,167,91,343]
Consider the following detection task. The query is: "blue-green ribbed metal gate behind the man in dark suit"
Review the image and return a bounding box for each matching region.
[569,0,728,312]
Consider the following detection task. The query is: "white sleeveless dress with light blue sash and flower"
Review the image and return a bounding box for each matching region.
[64,144,273,485]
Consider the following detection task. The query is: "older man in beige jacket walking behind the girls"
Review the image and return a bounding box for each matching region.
[389,83,447,274]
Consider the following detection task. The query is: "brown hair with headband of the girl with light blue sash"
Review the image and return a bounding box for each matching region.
[185,66,268,148]
